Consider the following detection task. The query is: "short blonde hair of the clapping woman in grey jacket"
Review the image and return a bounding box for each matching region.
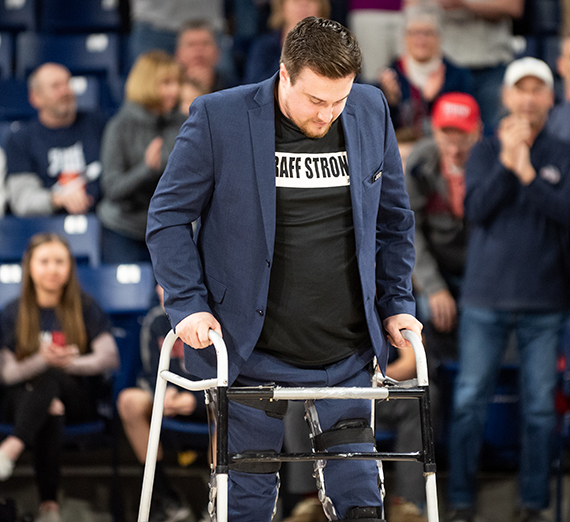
[125,50,182,110]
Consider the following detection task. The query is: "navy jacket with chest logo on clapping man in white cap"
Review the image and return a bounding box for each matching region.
[462,130,570,312]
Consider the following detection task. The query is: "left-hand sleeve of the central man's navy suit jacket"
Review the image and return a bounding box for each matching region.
[147,98,214,326]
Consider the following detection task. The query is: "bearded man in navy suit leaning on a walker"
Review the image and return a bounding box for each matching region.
[147,17,421,522]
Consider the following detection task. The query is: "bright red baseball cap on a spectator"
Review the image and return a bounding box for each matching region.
[431,92,481,132]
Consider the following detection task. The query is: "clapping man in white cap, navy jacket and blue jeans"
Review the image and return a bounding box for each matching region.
[449,57,570,522]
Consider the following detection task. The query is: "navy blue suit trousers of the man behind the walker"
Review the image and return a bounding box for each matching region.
[224,349,382,522]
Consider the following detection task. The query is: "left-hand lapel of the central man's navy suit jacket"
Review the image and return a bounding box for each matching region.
[248,76,276,257]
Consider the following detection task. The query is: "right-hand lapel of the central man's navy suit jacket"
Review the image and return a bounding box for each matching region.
[341,104,363,251]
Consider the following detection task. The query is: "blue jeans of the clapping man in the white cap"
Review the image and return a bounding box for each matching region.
[449,307,567,509]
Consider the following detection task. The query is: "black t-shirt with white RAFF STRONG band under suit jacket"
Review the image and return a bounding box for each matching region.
[256,100,369,366]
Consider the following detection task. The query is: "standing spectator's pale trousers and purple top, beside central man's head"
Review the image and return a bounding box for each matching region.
[348,0,406,83]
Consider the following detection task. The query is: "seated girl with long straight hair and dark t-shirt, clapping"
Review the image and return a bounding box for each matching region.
[0,234,119,522]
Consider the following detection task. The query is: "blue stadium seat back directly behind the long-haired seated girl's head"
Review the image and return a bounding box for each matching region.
[0,215,101,266]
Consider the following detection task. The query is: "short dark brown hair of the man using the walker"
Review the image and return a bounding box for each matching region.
[281,16,362,83]
